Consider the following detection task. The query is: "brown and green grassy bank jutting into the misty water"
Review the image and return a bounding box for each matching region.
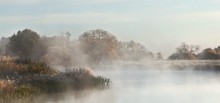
[0,57,111,103]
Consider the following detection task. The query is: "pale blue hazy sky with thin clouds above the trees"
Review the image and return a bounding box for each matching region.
[0,0,220,56]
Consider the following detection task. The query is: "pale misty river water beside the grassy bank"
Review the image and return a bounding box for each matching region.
[51,62,220,103]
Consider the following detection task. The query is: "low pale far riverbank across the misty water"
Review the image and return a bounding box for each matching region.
[96,60,220,71]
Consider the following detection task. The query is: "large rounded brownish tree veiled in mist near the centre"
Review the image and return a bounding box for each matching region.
[79,29,118,64]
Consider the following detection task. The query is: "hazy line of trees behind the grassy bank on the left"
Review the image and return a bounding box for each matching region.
[0,29,160,66]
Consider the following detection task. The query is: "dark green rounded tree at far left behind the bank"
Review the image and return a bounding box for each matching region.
[7,29,40,59]
